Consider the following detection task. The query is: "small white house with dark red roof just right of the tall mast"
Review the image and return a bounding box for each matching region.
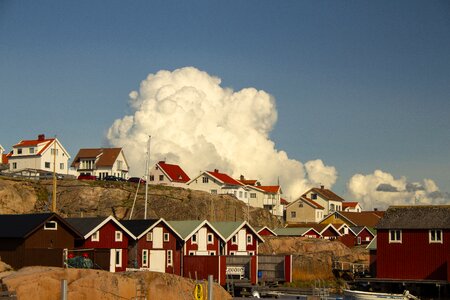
[148,161,190,187]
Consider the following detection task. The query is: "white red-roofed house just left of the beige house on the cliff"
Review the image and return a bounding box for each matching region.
[247,185,283,217]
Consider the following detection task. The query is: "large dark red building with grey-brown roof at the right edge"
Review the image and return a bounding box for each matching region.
[376,205,450,282]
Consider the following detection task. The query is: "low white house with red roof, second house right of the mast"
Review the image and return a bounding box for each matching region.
[186,169,248,203]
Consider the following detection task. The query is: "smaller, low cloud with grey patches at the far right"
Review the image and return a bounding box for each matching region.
[347,170,450,210]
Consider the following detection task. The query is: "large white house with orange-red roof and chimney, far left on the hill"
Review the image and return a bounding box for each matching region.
[8,134,70,174]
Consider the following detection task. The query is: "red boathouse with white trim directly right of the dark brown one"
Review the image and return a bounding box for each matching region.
[66,216,136,272]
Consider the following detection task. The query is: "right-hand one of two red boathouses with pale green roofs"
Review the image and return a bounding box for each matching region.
[211,221,264,255]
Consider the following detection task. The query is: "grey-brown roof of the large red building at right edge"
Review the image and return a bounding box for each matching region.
[376,205,450,229]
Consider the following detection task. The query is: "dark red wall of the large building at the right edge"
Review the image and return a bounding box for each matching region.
[376,229,450,281]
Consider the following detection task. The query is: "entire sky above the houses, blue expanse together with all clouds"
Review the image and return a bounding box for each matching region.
[0,0,450,208]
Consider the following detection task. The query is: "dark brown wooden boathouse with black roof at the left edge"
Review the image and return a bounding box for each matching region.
[0,213,81,269]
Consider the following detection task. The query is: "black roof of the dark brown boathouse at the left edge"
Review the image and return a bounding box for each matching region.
[0,213,82,238]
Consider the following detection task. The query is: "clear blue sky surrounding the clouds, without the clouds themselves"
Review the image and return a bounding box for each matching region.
[0,0,450,194]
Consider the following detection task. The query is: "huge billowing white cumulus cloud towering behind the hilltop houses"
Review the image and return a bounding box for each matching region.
[107,67,337,199]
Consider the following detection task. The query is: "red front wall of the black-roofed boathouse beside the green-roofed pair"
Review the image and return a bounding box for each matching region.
[136,225,183,275]
